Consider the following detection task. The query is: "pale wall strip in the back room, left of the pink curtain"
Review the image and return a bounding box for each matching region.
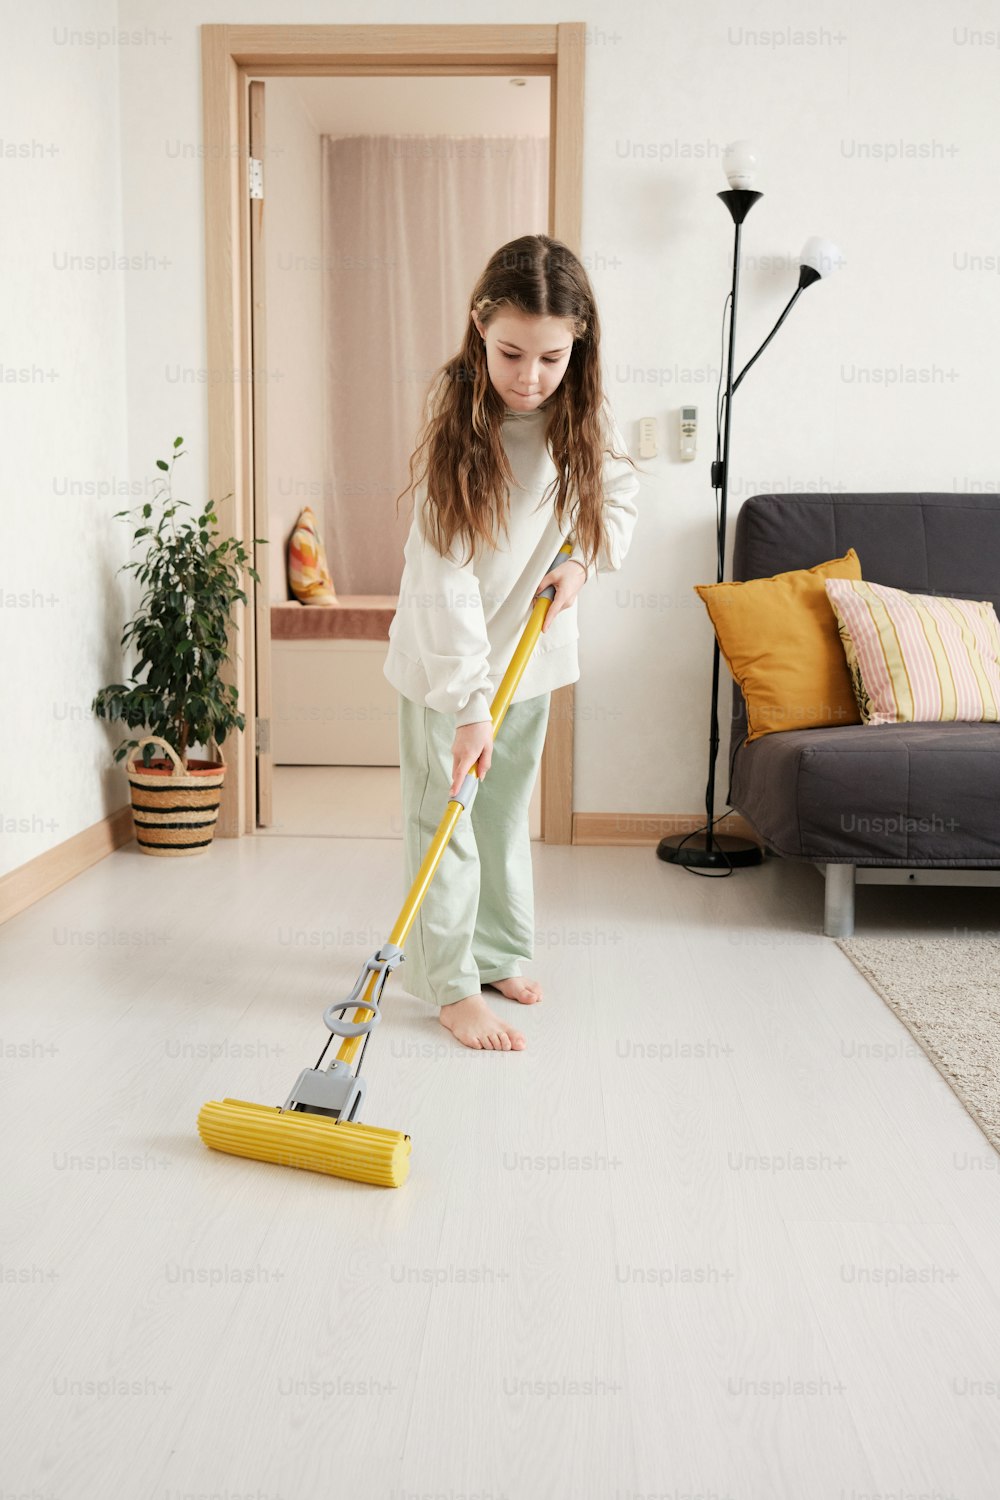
[264,78,327,603]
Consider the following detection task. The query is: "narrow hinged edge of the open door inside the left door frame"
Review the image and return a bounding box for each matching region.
[247,81,277,828]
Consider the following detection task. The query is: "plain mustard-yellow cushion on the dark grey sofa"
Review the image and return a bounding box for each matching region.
[694,548,861,741]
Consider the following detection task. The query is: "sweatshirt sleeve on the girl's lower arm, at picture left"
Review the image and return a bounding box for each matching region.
[405,485,490,725]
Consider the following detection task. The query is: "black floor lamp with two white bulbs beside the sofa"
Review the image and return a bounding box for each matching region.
[657,141,841,875]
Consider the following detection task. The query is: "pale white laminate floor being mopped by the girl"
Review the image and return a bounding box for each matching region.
[0,834,1000,1500]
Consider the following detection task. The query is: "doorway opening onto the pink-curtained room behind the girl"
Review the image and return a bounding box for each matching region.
[249,74,550,839]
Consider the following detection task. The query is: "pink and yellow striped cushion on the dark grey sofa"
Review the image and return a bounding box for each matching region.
[825,578,1000,725]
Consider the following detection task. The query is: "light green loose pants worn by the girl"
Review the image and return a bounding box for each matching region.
[397,693,550,1005]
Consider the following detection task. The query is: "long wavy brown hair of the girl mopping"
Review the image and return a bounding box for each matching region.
[396,234,636,566]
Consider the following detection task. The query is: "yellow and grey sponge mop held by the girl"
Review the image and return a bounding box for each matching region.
[198,542,573,1188]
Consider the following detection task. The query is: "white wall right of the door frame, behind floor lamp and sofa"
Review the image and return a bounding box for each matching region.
[566,0,1000,812]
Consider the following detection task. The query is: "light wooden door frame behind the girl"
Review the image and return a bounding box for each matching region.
[199,21,586,843]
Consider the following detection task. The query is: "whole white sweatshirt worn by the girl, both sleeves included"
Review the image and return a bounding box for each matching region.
[384,407,639,726]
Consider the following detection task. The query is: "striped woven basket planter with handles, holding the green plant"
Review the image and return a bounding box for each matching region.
[124,735,226,855]
